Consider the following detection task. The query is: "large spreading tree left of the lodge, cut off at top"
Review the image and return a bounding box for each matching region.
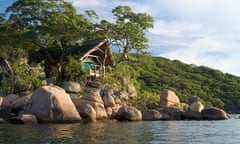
[7,0,93,77]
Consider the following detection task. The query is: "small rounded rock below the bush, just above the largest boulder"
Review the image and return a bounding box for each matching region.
[62,81,81,93]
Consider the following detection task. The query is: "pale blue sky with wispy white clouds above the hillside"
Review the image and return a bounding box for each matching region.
[0,0,240,76]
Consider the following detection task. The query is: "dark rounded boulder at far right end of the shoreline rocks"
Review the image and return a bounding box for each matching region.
[201,107,229,120]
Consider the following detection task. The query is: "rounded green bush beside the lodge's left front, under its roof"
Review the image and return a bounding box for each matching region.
[63,56,87,81]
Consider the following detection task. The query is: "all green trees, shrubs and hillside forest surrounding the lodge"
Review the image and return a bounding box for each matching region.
[0,0,240,112]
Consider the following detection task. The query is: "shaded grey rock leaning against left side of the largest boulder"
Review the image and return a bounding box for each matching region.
[11,96,31,114]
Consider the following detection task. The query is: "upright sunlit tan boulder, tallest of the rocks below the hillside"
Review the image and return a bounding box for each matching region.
[159,90,180,107]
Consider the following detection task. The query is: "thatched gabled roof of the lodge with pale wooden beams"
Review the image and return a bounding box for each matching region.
[64,38,114,65]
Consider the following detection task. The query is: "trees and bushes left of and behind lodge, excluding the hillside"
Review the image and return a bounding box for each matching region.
[0,0,153,93]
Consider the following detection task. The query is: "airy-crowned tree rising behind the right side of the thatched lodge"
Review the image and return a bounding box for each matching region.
[96,6,154,60]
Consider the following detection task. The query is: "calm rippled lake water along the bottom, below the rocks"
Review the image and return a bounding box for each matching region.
[0,115,240,144]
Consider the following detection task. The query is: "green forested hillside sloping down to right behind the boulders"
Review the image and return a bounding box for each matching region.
[114,55,240,112]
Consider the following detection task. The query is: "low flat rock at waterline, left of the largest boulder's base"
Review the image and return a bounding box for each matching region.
[7,114,38,124]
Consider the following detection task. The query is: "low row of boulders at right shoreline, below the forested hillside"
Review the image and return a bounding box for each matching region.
[142,90,229,120]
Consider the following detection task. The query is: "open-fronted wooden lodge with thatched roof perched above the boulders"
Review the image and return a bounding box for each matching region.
[64,38,114,79]
